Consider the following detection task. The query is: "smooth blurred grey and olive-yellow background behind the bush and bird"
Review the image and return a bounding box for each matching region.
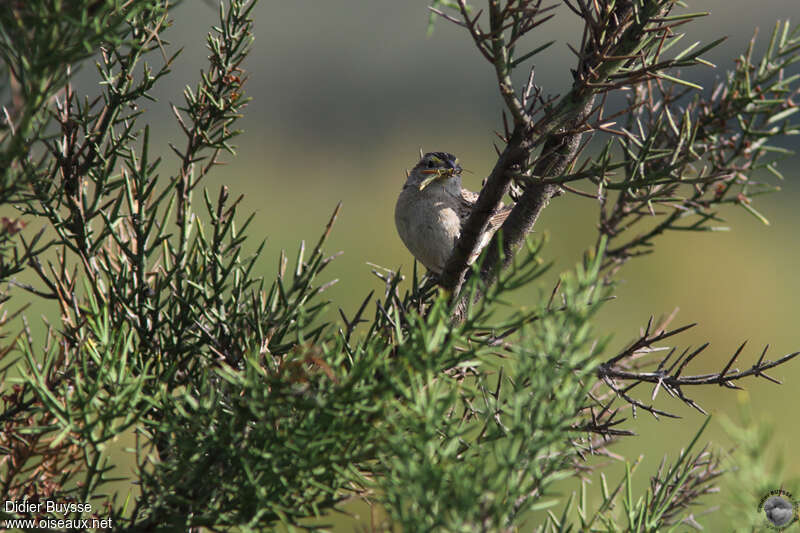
[50,0,800,531]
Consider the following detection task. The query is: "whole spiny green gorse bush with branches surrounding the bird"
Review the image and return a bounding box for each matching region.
[0,0,800,532]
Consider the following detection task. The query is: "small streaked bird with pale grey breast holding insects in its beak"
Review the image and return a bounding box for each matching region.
[394,152,512,276]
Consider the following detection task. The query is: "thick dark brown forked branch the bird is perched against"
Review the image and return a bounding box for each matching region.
[439,2,680,321]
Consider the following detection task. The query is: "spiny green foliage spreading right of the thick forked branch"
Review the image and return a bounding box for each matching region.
[596,21,800,264]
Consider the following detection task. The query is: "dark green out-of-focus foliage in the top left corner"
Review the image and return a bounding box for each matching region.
[0,0,166,198]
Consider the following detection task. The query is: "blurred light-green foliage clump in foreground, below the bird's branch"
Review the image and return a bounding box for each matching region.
[379,240,607,531]
